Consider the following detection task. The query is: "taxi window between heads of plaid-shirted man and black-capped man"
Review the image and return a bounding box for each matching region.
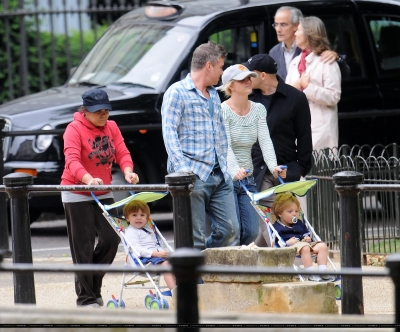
[208,26,259,67]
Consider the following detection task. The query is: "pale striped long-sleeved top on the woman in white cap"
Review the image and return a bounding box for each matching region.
[221,102,277,180]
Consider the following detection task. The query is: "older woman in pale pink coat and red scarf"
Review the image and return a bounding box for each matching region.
[286,16,341,150]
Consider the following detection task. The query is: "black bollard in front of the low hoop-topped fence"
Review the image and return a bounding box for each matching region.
[333,171,364,315]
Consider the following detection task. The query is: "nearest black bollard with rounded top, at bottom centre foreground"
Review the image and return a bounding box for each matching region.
[168,248,204,332]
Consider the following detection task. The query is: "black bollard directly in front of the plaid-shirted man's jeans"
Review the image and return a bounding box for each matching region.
[165,173,196,248]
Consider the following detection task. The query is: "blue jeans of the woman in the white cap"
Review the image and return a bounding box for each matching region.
[233,175,260,245]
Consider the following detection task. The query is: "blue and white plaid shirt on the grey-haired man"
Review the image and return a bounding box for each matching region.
[161,73,230,181]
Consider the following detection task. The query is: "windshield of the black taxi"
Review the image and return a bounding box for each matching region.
[68,24,195,88]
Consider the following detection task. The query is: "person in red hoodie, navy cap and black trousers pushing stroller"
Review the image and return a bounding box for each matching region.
[61,89,139,307]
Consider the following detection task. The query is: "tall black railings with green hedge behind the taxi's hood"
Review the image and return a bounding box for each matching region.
[0,0,146,103]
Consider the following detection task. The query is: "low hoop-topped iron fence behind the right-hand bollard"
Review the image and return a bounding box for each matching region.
[307,144,400,254]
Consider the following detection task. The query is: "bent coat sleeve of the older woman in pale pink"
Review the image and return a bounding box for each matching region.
[303,60,342,106]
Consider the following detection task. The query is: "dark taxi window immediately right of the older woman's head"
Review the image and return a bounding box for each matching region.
[322,15,362,78]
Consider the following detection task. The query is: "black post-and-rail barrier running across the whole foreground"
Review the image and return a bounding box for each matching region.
[0,171,400,331]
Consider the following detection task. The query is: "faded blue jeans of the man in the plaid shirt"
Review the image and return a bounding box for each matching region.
[191,168,239,250]
